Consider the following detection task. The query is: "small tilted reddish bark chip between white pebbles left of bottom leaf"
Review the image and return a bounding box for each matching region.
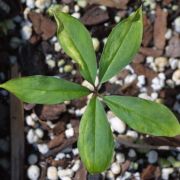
[48,133,65,149]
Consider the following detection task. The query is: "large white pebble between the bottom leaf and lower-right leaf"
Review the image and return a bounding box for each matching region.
[108,116,126,134]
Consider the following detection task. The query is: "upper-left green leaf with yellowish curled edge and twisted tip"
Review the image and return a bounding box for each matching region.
[50,7,97,83]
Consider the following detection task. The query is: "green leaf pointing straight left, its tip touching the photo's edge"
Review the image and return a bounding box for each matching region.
[0,76,90,104]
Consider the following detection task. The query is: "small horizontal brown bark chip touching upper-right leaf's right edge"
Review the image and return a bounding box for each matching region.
[139,47,163,57]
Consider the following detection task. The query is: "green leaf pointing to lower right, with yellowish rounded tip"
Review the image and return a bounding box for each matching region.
[104,96,180,137]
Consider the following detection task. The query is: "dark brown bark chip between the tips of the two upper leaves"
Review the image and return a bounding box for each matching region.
[81,6,109,26]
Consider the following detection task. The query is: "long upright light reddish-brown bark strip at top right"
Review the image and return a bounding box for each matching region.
[153,6,168,49]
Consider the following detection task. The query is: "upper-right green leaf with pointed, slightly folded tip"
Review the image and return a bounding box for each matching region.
[99,8,143,83]
